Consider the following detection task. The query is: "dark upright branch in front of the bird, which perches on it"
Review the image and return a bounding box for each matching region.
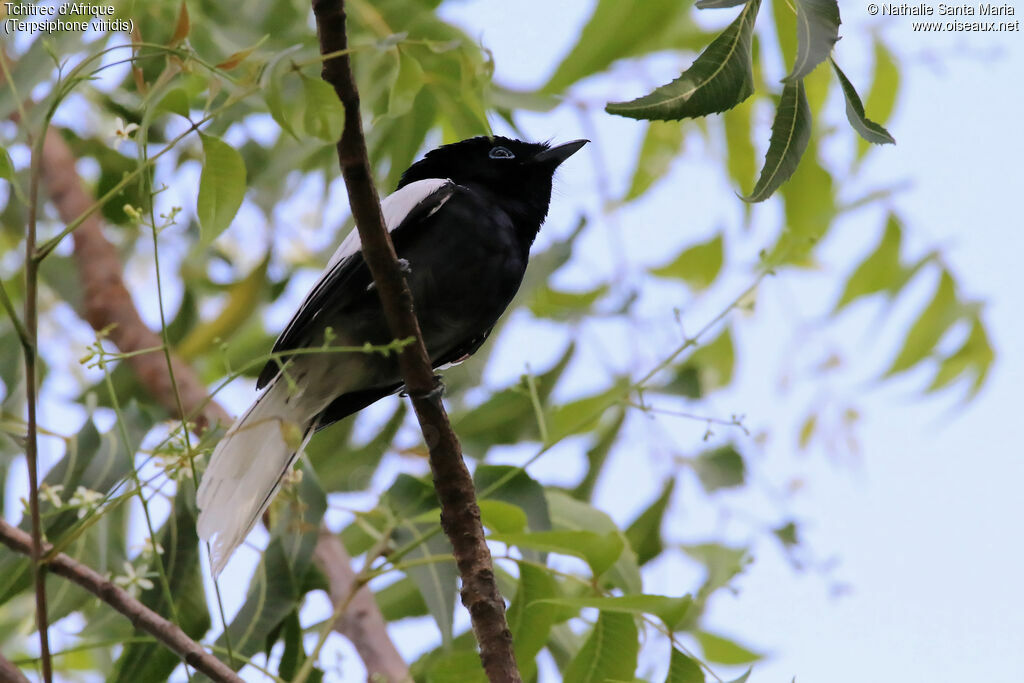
[312,0,520,682]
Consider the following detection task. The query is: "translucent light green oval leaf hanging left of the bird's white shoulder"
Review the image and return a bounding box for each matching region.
[196,134,246,244]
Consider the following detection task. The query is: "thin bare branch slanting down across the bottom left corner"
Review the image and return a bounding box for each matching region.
[0,519,242,683]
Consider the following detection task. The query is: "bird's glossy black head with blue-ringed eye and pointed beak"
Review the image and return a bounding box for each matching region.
[398,136,589,241]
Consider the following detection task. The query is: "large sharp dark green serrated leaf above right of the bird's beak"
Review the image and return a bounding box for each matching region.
[605,0,761,120]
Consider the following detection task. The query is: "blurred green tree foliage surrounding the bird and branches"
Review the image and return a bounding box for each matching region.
[0,0,994,682]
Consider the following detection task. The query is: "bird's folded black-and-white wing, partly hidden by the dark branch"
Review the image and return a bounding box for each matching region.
[256,178,456,389]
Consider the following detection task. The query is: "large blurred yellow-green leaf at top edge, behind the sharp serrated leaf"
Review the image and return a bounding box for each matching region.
[543,0,703,93]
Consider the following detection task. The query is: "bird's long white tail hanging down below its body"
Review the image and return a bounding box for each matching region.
[196,376,313,575]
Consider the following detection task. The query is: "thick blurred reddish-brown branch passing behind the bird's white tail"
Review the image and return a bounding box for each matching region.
[32,124,409,681]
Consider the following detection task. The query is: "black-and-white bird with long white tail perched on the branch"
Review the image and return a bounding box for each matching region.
[197,136,589,575]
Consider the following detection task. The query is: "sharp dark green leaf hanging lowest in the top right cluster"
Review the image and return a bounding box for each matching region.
[743,81,811,202]
